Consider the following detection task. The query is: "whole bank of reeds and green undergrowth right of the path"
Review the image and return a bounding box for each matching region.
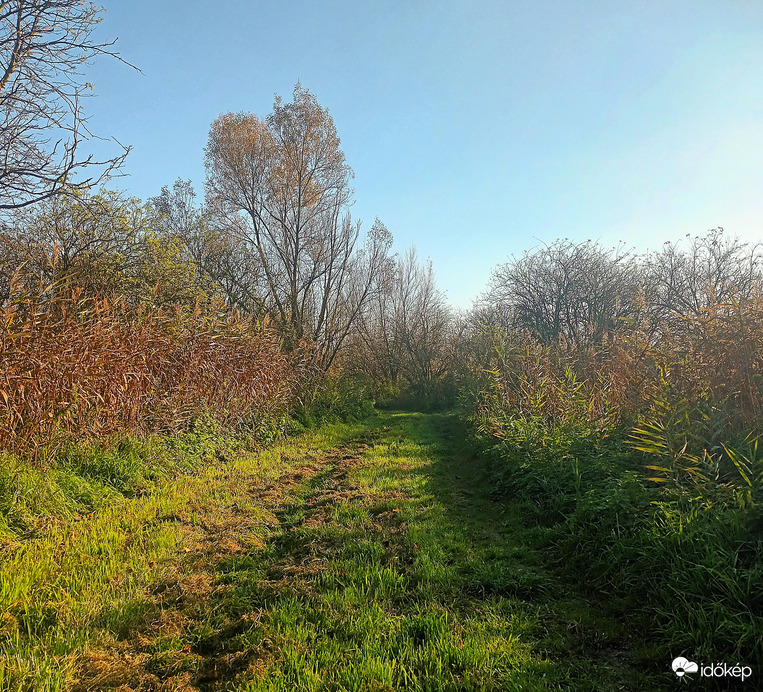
[466,299,763,662]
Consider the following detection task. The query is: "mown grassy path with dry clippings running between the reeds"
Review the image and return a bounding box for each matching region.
[1,414,661,692]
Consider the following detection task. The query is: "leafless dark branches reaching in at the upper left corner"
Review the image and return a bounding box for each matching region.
[0,0,134,210]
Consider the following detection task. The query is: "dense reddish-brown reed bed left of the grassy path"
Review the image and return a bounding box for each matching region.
[0,293,303,457]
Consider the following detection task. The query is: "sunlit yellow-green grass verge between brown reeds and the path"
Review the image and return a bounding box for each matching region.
[0,418,364,691]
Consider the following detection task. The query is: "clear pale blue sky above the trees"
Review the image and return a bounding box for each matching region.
[80,0,763,307]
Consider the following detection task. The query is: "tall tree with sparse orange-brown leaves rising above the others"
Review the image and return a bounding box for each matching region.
[206,84,391,367]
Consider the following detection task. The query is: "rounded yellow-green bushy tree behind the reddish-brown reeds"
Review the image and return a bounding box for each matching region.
[0,190,208,305]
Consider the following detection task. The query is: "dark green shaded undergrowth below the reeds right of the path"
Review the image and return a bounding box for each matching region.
[472,398,763,661]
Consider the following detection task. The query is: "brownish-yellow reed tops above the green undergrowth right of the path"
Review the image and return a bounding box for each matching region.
[479,296,763,460]
